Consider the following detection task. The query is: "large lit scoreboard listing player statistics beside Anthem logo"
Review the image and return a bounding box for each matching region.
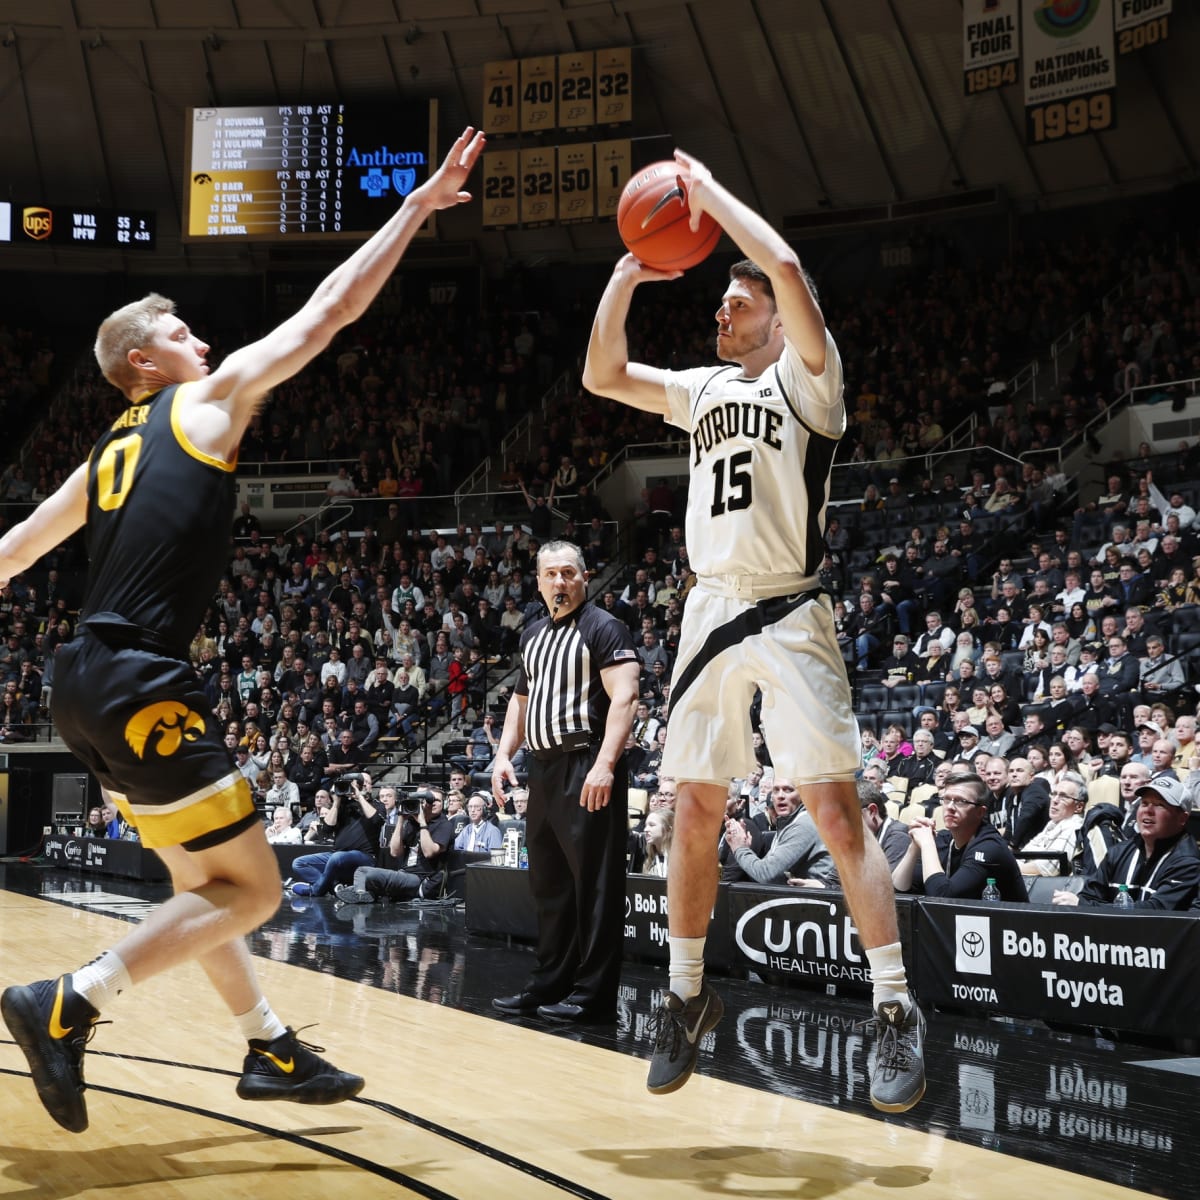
[184,100,438,241]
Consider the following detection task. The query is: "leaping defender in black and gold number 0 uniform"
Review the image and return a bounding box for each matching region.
[0,128,484,1132]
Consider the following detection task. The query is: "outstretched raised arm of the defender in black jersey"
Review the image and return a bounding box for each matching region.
[199,126,485,438]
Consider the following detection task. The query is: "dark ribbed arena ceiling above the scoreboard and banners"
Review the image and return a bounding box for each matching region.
[0,0,1200,270]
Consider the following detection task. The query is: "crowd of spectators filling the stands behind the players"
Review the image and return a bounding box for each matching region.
[0,208,1200,916]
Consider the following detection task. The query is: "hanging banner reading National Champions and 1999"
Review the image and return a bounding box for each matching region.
[1021,0,1116,145]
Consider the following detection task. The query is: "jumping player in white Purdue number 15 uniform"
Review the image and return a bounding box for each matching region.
[583,150,925,1112]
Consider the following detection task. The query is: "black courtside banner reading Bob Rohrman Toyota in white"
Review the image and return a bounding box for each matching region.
[917,900,1200,1036]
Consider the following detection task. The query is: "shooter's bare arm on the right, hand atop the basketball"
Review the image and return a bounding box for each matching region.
[674,150,826,376]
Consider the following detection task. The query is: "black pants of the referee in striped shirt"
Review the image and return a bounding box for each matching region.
[526,746,629,1016]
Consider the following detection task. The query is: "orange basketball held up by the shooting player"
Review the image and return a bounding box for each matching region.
[617,161,721,271]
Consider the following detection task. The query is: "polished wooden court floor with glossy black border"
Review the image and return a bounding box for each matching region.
[0,865,1185,1200]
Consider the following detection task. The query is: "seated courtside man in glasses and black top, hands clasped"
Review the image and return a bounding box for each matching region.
[892,774,1030,904]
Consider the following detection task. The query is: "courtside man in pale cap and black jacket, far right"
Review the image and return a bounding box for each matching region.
[1054,775,1200,912]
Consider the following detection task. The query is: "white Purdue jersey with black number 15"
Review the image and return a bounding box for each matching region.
[665,330,846,576]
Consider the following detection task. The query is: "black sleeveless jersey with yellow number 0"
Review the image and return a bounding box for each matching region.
[83,384,235,658]
